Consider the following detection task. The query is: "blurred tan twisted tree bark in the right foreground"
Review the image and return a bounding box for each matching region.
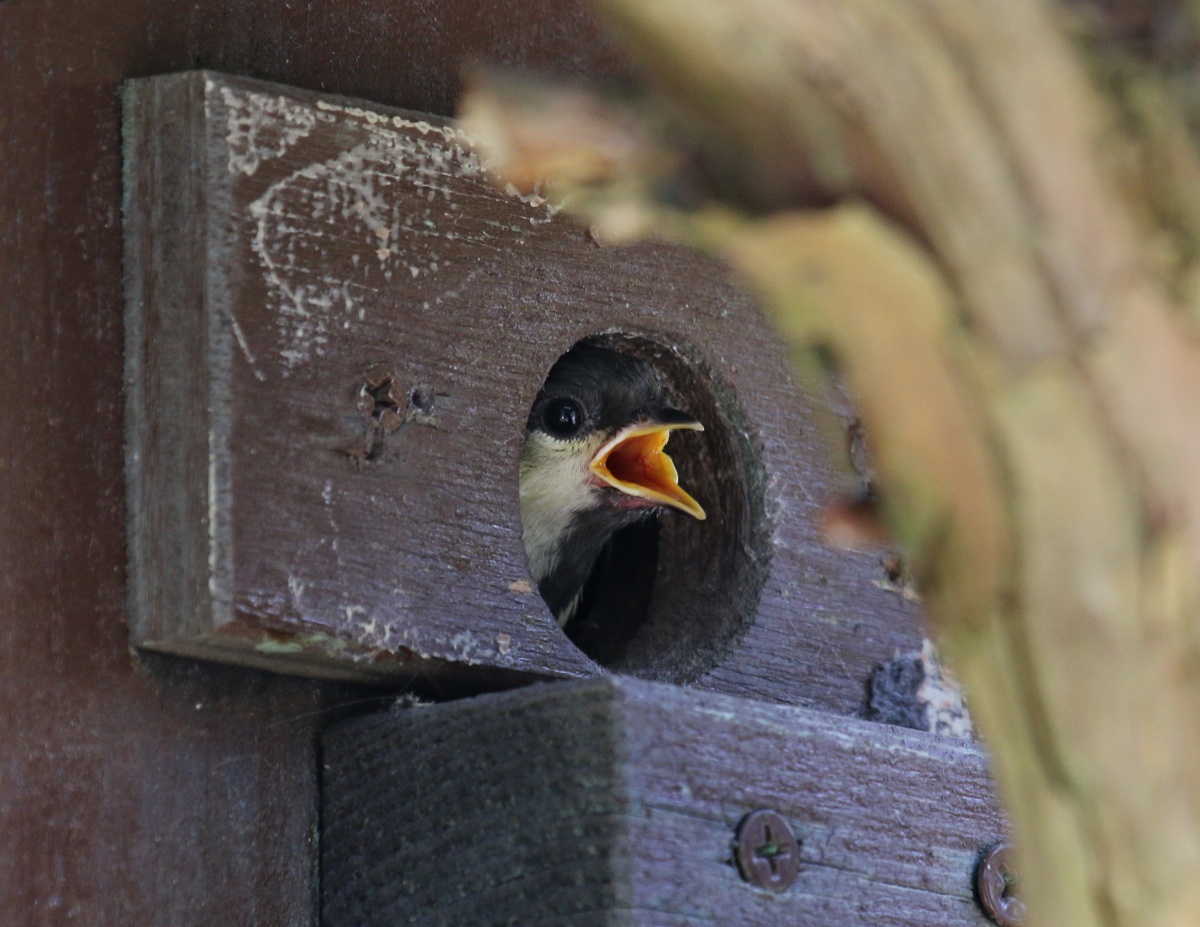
[463,0,1200,927]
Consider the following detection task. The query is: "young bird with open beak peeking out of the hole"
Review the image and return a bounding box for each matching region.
[521,343,704,626]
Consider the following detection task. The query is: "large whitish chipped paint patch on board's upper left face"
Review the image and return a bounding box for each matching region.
[221,88,558,379]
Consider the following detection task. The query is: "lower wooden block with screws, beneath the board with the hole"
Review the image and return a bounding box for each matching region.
[322,677,1004,927]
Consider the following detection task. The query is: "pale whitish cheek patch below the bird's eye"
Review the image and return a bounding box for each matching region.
[521,431,593,581]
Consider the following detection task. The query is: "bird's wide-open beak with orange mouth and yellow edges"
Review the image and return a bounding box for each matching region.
[588,409,706,521]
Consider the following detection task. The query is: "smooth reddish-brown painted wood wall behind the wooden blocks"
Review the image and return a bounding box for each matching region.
[0,0,617,927]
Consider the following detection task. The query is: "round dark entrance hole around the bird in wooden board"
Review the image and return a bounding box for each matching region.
[518,333,770,683]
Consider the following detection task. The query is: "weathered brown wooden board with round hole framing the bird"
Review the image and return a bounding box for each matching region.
[125,72,919,712]
